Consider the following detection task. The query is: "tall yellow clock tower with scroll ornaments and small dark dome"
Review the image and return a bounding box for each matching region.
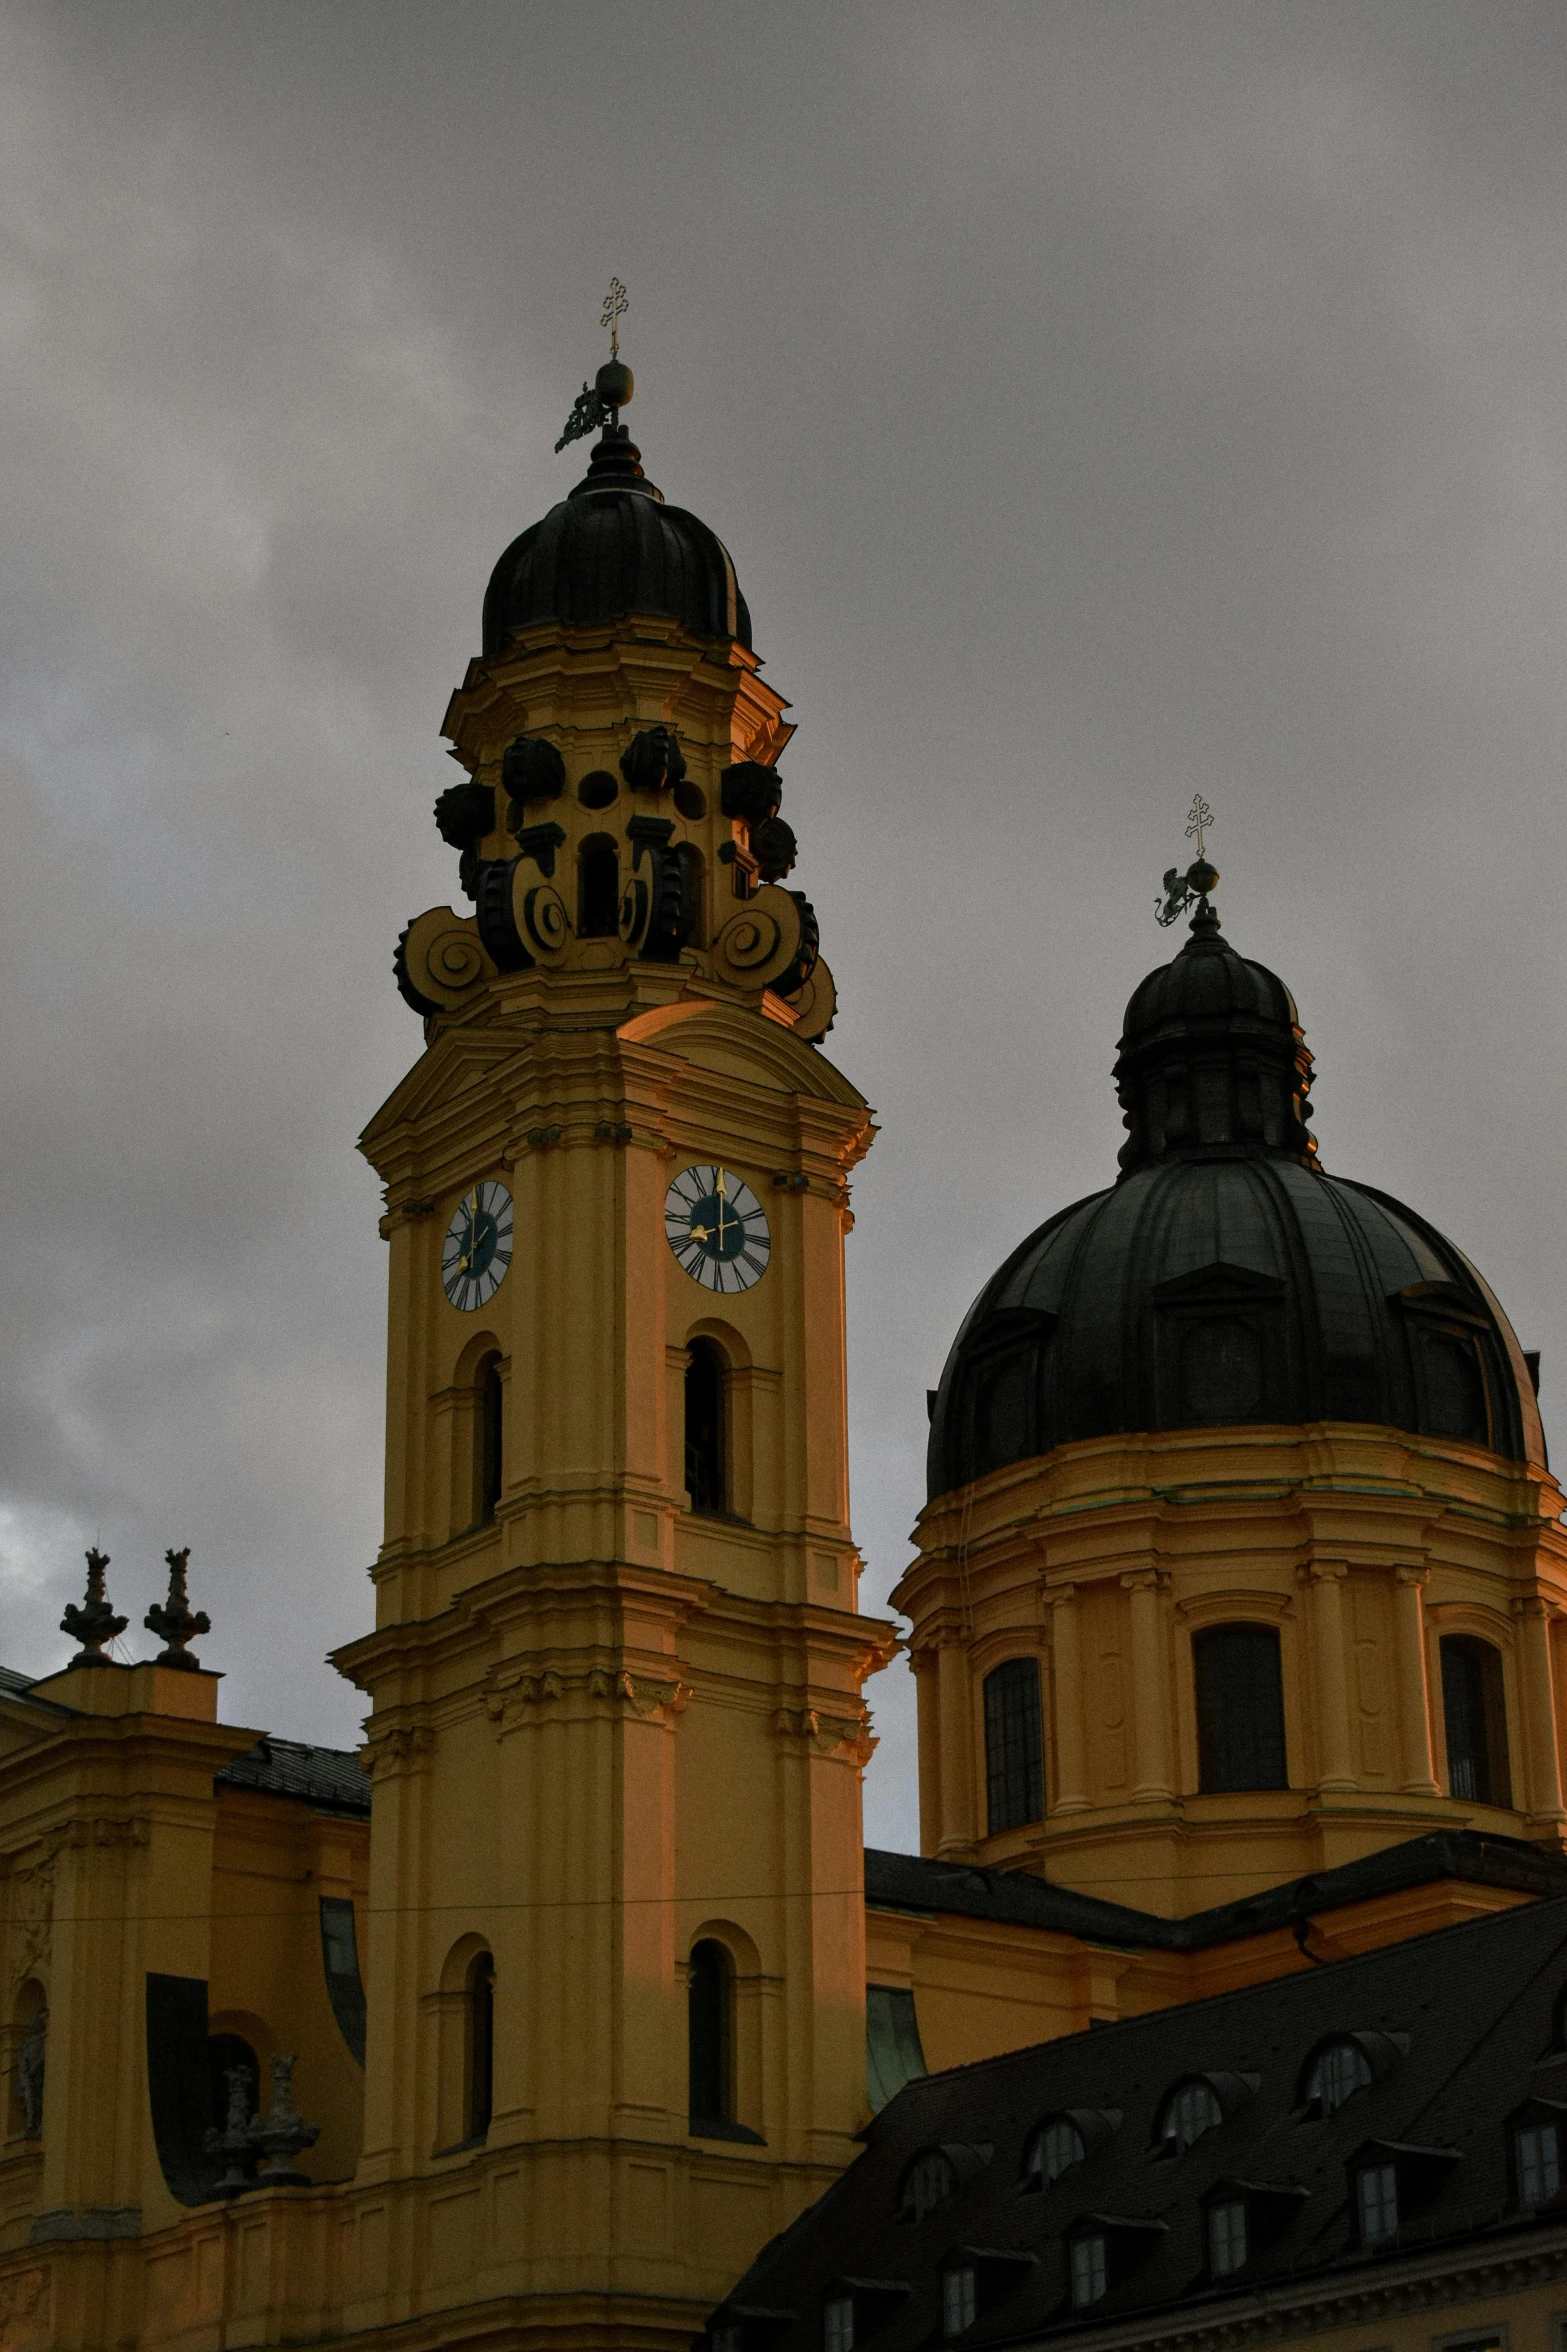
[336,358,892,2345]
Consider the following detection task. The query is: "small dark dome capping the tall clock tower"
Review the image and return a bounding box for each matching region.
[485,426,751,659]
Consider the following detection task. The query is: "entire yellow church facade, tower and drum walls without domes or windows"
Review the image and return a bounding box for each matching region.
[0,458,1567,2352]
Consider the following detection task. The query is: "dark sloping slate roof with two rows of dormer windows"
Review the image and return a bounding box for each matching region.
[715,1896,1567,2352]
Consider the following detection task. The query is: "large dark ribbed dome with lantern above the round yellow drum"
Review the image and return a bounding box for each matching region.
[929,908,1546,1496]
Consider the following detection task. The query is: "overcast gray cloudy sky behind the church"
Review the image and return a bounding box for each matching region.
[0,0,1567,1844]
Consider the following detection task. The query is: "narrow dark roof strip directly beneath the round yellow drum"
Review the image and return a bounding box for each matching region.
[866,1830,1567,1952]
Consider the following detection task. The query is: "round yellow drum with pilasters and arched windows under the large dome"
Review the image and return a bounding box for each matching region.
[894,1411,1567,1917]
